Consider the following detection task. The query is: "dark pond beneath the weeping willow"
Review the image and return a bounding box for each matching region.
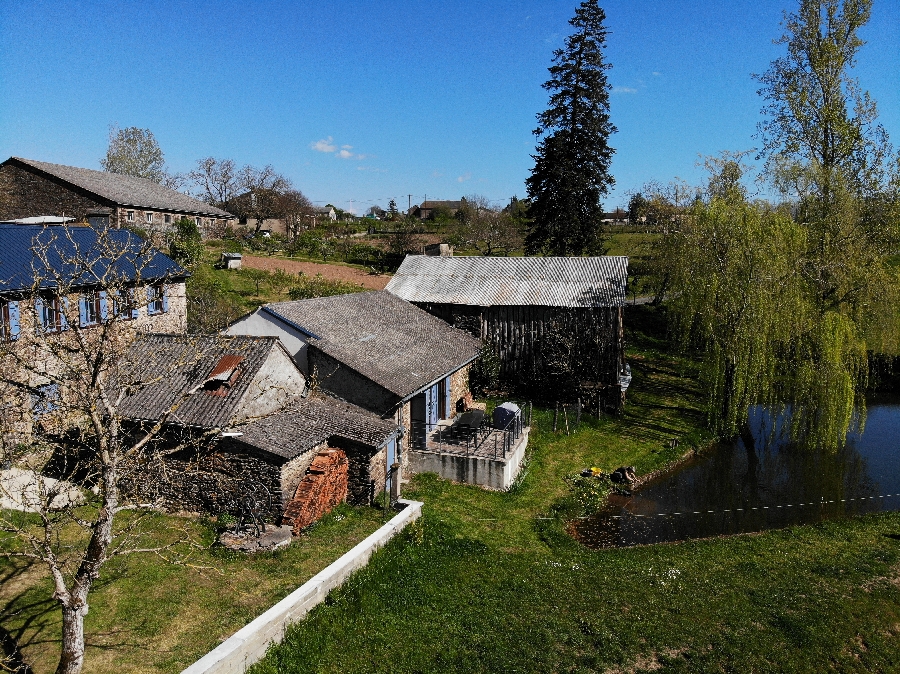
[575,397,900,548]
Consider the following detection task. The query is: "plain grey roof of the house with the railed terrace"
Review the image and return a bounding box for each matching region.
[263,290,481,398]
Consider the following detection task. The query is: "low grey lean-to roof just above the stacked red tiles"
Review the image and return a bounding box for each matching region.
[229,394,399,459]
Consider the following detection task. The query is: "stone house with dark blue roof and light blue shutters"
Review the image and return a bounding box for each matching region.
[0,225,188,438]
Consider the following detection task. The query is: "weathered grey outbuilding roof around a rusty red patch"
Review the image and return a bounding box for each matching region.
[117,334,284,428]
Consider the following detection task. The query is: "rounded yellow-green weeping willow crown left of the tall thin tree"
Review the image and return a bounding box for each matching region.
[662,184,807,435]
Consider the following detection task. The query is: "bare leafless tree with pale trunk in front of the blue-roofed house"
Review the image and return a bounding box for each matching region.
[0,227,225,674]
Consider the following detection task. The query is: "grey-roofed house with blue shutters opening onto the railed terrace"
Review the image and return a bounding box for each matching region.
[225,291,481,463]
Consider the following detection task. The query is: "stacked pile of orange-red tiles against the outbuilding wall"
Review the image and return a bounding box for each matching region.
[281,449,348,535]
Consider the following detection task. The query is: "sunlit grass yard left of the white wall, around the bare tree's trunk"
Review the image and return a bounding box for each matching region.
[0,506,390,674]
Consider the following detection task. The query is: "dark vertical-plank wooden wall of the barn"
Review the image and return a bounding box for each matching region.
[414,302,624,387]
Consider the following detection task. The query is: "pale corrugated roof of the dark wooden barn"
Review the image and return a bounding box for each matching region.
[385,255,628,307]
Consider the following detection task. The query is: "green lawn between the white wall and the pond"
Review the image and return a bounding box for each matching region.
[252,308,900,674]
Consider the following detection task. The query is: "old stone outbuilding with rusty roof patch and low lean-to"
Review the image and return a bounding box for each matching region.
[119,334,399,528]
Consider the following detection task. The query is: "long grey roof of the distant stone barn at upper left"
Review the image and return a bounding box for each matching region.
[3,157,234,218]
